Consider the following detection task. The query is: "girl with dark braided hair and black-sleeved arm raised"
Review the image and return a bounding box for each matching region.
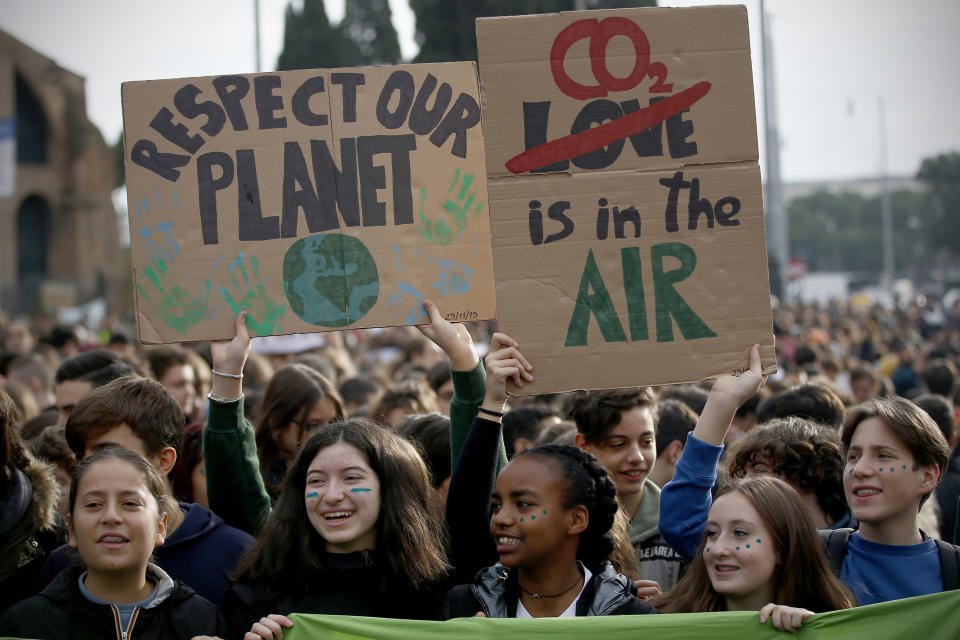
[444,334,656,618]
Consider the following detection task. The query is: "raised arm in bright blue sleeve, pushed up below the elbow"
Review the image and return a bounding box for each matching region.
[659,345,764,561]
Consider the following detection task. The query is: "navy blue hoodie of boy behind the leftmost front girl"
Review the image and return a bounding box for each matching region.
[43,502,253,610]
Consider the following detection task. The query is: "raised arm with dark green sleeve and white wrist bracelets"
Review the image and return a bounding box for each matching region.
[203,311,270,535]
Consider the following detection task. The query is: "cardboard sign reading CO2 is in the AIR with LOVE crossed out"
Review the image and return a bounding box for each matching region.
[477,6,776,394]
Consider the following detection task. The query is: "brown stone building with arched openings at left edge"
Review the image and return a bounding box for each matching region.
[0,31,128,315]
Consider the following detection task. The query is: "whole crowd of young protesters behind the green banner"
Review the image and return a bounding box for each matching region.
[0,300,960,640]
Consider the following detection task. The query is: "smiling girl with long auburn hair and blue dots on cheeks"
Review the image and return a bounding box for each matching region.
[652,477,856,631]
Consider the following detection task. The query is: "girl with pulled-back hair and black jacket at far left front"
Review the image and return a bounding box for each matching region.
[0,449,226,640]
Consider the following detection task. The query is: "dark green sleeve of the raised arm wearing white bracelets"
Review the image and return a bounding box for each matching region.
[203,398,270,535]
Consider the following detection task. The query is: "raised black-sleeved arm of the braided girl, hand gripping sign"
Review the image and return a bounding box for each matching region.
[447,333,533,582]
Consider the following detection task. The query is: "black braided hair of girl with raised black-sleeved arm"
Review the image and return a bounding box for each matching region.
[516,444,620,571]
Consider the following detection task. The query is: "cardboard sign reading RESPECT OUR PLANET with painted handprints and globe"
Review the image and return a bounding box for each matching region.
[123,62,495,343]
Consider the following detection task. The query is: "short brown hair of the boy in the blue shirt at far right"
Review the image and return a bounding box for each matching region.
[840,397,950,505]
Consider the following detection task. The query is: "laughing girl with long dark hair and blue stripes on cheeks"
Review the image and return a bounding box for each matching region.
[226,419,447,640]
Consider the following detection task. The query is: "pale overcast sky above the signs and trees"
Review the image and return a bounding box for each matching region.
[0,0,960,181]
